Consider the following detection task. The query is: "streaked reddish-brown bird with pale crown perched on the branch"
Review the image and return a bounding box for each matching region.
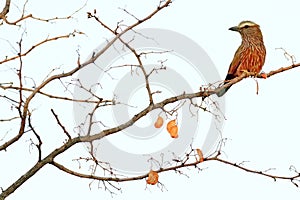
[216,21,266,97]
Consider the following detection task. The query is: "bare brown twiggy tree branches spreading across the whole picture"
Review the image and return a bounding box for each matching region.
[0,0,300,199]
